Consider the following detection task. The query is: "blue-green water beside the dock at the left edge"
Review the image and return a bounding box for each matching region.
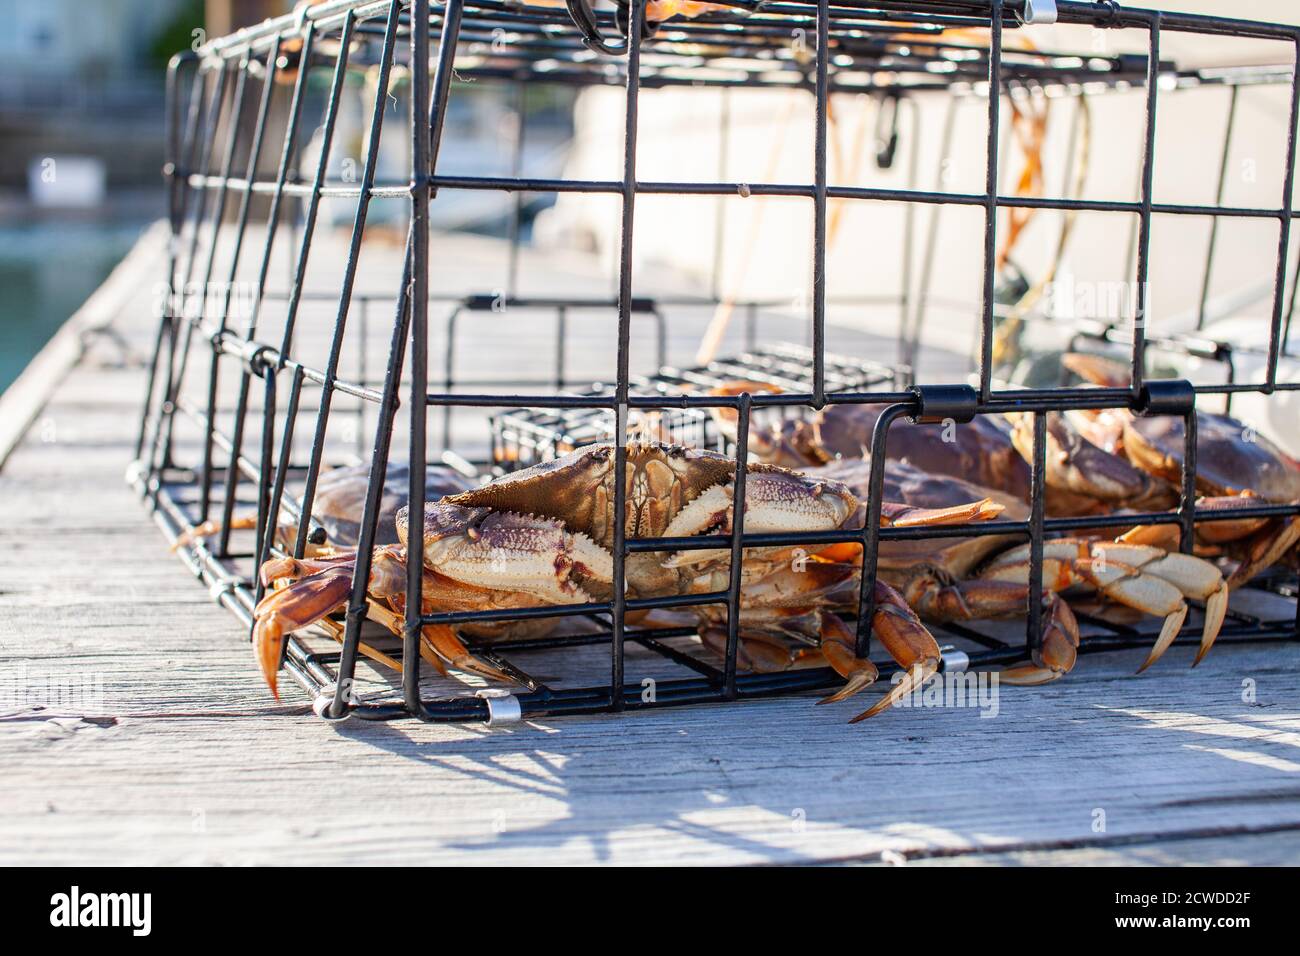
[0,221,147,392]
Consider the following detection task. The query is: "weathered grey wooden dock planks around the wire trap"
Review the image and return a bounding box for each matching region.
[0,230,1300,864]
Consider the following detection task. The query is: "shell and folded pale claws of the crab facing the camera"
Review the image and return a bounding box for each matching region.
[397,442,858,604]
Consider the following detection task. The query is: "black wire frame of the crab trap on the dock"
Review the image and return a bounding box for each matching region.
[133,0,1300,721]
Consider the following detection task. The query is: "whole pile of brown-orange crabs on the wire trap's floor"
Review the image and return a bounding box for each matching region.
[226,355,1300,721]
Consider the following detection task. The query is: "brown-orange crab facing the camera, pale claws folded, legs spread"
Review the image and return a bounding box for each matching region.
[254,444,998,719]
